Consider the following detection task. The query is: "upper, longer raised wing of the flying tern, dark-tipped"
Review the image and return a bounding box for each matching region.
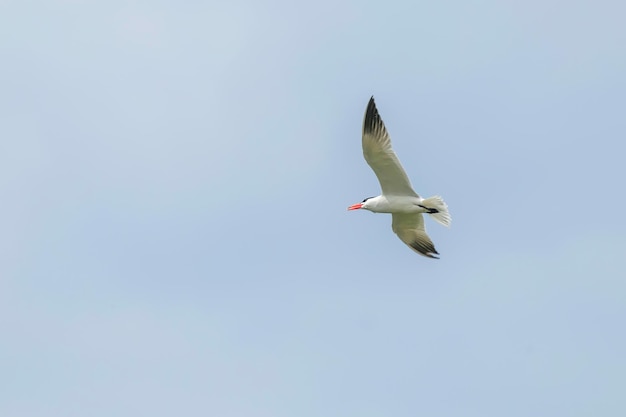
[363,97,418,197]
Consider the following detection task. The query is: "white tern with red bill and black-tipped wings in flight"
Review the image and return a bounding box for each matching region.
[348,97,451,259]
